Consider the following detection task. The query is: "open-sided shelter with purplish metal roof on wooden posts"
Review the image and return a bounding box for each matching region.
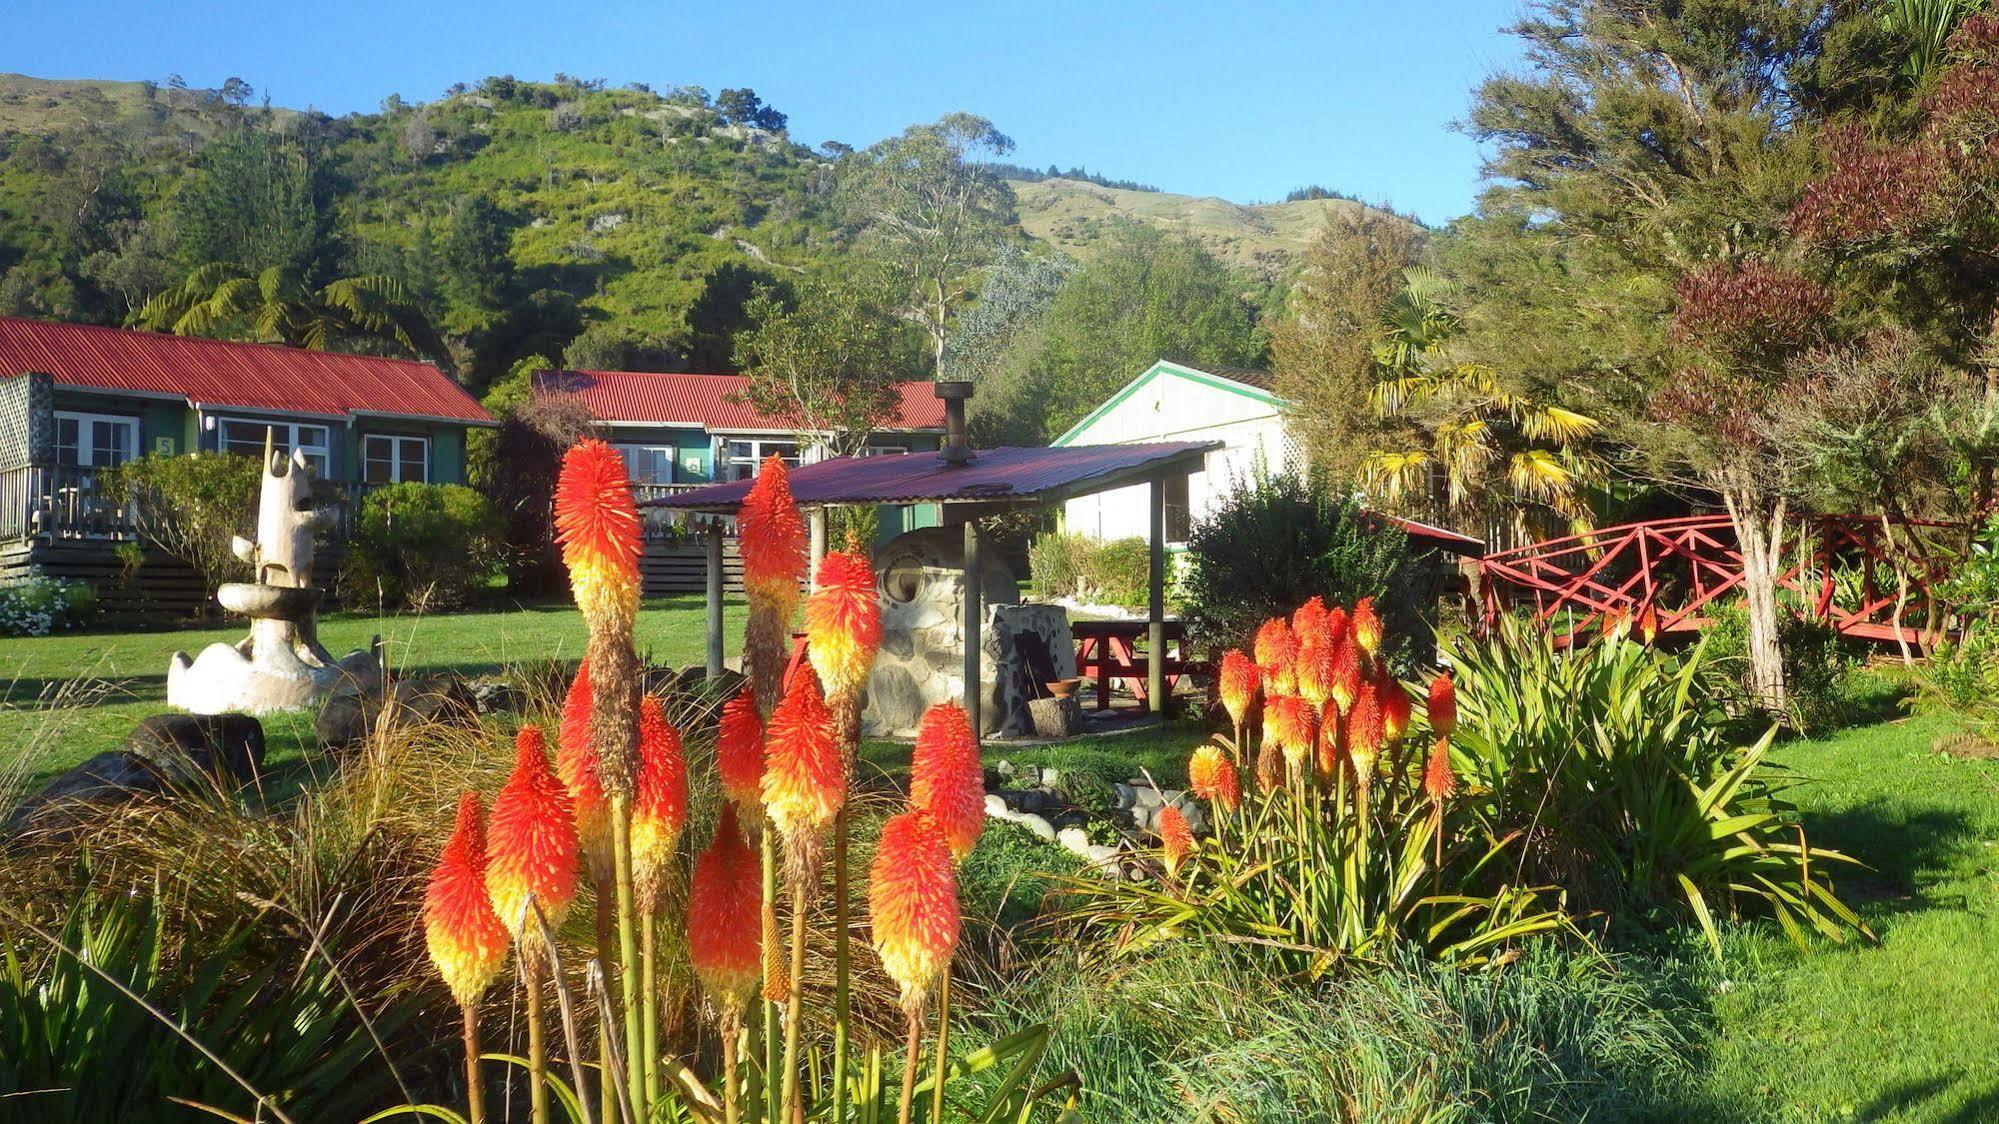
[644,434,1221,730]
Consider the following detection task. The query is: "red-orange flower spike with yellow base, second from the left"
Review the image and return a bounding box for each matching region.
[486,726,578,944]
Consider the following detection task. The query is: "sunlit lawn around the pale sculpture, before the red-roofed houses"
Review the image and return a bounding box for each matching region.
[0,594,744,778]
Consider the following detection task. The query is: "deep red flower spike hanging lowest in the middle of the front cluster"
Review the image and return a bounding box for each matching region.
[688,804,764,1014]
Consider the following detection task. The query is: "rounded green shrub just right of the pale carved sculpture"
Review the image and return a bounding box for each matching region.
[340,482,500,610]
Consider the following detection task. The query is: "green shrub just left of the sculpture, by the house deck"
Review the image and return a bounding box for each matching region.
[102,452,264,590]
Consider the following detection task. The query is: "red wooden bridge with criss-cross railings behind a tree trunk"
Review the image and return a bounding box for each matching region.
[1479,514,1959,646]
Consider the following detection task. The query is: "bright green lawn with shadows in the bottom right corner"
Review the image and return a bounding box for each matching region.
[1707,718,1999,1124]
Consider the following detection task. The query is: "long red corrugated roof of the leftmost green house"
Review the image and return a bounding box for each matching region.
[0,316,494,422]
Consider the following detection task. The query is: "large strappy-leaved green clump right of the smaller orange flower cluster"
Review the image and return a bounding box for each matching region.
[1447,620,1871,956]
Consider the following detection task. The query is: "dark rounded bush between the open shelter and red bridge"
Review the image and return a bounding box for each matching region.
[1181,474,1435,664]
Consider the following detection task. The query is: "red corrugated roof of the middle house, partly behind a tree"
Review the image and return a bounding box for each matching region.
[534,370,944,432]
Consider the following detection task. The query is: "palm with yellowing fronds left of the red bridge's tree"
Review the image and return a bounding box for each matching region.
[1361,268,1605,536]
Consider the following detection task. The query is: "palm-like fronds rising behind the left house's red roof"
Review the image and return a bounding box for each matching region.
[132,262,446,362]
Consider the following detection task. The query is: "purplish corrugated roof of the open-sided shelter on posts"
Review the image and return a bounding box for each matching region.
[646,442,1221,512]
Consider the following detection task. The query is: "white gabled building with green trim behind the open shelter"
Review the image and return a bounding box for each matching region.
[1051,360,1301,544]
